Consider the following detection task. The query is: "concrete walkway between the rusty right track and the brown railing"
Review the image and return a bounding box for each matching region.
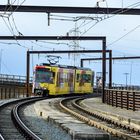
[82,97,140,130]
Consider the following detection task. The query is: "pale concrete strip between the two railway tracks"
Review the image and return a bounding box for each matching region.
[34,99,110,140]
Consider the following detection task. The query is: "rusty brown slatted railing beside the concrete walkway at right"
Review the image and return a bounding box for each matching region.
[105,89,140,111]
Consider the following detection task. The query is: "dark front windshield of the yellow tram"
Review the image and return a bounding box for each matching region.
[35,70,53,83]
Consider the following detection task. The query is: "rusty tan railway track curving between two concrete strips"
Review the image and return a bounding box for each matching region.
[60,98,140,140]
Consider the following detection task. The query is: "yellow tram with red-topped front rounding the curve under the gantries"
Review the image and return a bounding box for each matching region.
[32,63,94,96]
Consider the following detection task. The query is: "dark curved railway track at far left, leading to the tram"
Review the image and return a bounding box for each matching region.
[0,98,42,140]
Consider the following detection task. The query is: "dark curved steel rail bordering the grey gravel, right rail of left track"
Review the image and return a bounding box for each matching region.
[12,98,44,140]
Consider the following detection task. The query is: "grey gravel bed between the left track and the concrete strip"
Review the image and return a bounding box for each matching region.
[24,105,71,140]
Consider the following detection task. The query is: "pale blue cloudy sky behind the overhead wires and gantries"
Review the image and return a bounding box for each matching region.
[0,0,140,84]
